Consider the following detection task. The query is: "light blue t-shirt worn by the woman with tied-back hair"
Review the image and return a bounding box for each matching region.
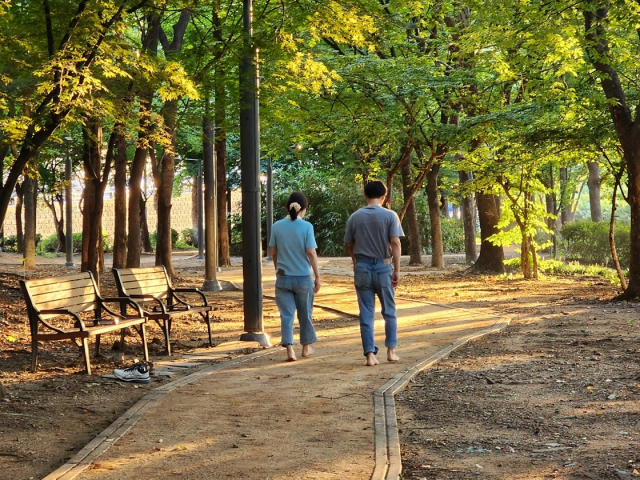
[269,217,318,277]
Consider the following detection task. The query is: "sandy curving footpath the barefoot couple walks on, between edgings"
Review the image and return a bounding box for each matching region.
[50,272,498,480]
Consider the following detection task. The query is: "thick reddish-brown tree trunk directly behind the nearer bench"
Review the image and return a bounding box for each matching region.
[80,118,105,285]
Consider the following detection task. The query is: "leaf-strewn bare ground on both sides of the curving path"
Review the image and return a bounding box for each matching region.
[0,254,640,479]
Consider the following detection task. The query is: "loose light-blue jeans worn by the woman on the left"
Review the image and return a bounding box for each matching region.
[276,275,318,347]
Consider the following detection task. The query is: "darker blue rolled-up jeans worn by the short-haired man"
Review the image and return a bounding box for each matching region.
[353,257,398,356]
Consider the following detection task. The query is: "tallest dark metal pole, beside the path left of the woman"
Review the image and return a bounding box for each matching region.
[240,0,271,346]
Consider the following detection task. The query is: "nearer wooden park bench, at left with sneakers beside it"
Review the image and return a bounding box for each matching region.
[20,272,149,375]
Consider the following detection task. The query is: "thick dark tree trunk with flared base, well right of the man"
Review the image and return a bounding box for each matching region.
[471,192,505,274]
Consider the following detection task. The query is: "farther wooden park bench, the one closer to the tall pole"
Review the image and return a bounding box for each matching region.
[113,266,213,355]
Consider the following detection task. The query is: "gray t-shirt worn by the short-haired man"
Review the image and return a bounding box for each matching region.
[344,205,404,258]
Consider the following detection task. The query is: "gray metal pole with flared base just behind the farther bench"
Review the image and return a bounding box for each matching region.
[201,118,222,292]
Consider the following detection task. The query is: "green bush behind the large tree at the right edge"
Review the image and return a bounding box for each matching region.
[559,220,630,268]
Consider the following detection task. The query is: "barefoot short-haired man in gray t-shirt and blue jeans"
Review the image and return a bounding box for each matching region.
[344,180,404,367]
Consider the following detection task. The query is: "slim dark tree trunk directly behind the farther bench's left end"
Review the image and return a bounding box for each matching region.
[113,134,127,268]
